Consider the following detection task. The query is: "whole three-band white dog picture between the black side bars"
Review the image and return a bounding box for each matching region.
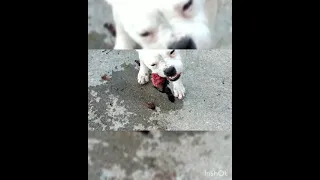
[88,0,232,180]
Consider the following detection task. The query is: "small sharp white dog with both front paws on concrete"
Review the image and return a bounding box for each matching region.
[136,49,185,99]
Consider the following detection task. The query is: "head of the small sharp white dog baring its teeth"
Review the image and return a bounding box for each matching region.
[136,49,183,81]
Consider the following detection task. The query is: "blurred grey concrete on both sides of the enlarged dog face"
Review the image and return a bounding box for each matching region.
[88,0,232,49]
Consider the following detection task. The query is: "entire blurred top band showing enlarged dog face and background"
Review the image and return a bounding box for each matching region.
[88,0,232,49]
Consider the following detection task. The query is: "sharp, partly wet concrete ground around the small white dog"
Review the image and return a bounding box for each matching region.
[88,49,232,131]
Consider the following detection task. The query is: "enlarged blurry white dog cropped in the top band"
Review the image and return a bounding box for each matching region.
[105,0,217,49]
